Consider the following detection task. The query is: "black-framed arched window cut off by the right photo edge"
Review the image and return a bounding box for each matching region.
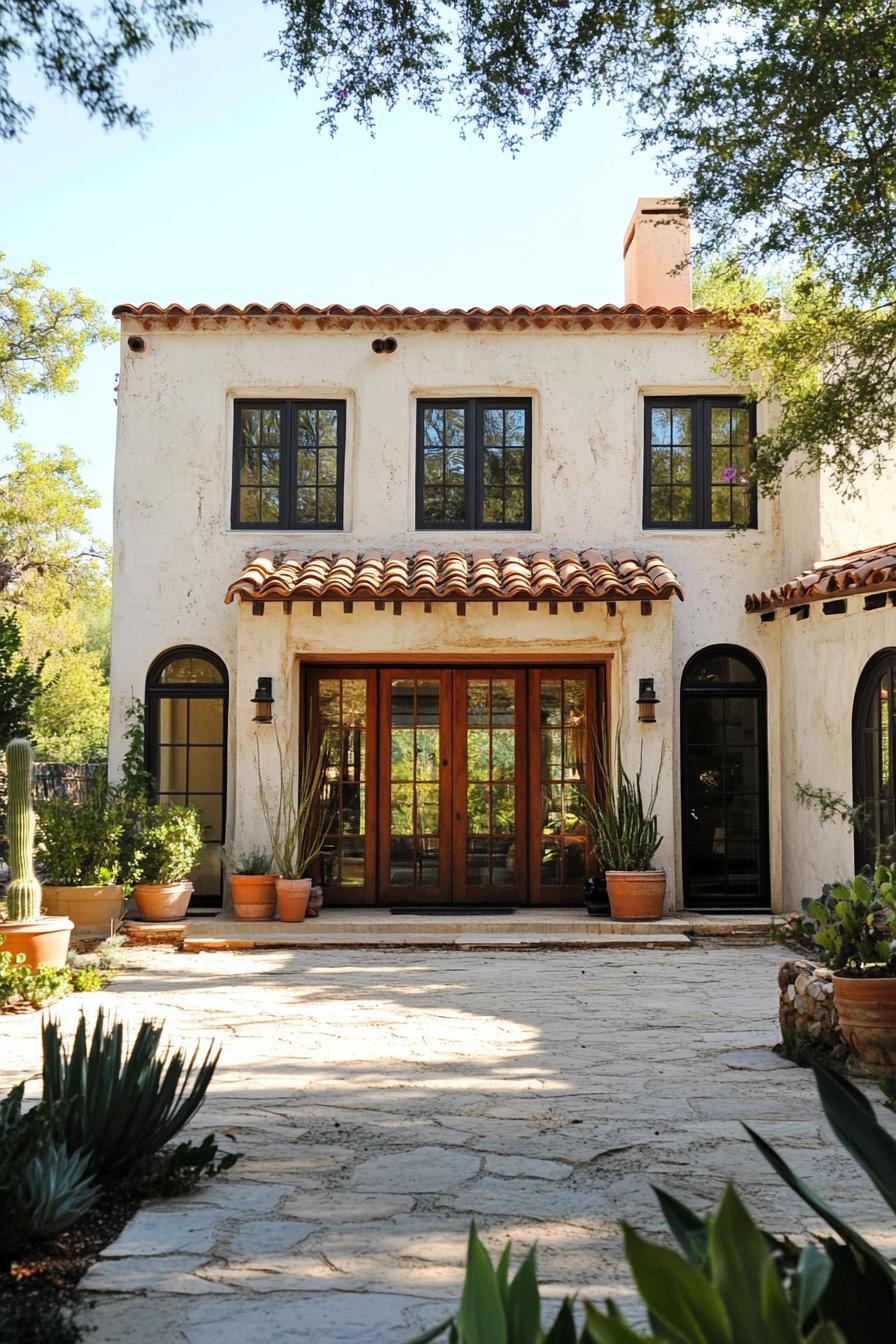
[853,649,896,868]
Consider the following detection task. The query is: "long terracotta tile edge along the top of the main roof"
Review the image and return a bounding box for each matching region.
[113,302,724,331]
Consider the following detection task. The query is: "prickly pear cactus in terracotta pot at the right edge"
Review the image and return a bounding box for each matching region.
[791,864,896,1070]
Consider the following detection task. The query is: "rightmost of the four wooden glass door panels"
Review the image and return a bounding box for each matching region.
[529,668,600,905]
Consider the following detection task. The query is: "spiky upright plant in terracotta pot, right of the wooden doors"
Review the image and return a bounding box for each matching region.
[582,731,666,919]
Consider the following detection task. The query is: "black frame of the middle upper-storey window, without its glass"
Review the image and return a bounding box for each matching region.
[414,396,532,532]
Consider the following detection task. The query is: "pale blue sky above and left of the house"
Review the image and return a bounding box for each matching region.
[0,0,672,538]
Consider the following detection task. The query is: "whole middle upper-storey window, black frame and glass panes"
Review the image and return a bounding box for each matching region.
[416,396,532,530]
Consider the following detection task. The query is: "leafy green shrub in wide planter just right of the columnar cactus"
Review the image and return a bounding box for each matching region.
[38,780,125,887]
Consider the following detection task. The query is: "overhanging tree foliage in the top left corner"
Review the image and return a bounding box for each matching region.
[0,0,208,140]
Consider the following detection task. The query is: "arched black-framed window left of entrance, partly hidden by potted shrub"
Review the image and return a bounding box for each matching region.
[146,646,227,907]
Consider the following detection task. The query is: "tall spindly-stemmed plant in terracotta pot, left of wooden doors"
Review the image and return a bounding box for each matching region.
[255,738,325,921]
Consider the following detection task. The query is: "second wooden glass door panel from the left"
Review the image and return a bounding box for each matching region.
[380,671,450,905]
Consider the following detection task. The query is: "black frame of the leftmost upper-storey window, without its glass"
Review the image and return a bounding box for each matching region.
[230,396,347,532]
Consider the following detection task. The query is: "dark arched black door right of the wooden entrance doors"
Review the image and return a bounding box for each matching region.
[681,644,771,913]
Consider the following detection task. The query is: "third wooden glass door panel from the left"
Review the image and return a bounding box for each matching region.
[454,671,527,905]
